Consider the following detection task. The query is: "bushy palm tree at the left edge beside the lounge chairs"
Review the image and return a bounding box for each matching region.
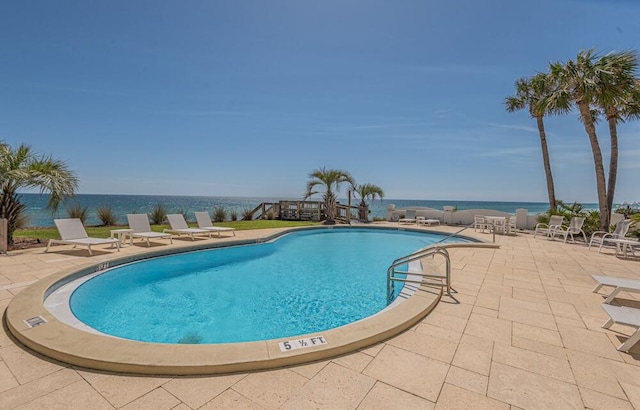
[0,142,78,244]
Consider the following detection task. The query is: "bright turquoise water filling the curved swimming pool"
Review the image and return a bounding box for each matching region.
[70,229,470,343]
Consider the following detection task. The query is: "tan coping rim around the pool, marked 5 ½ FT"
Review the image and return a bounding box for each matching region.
[5,226,490,375]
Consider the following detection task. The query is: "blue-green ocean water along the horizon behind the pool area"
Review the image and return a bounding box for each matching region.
[13,194,576,227]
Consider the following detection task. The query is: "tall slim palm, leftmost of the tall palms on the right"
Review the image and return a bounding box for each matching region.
[504,73,557,210]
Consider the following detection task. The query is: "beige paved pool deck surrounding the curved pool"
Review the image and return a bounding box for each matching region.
[0,224,640,410]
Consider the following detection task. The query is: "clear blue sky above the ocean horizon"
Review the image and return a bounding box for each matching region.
[0,0,640,202]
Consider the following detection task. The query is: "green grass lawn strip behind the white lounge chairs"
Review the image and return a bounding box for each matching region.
[13,219,318,241]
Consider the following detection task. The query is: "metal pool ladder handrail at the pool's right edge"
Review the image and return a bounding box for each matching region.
[387,243,452,305]
